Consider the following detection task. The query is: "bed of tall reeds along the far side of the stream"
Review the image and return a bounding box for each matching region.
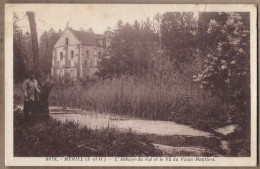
[46,76,227,128]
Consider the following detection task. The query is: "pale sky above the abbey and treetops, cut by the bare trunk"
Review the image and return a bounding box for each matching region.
[16,4,181,36]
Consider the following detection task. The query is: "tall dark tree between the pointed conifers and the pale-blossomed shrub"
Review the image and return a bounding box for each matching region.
[160,12,196,71]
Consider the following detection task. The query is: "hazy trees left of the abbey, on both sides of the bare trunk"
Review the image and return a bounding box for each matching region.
[13,13,61,83]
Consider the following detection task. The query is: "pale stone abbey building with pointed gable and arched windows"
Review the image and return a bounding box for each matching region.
[51,27,110,78]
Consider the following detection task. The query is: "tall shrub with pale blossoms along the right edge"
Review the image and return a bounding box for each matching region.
[194,13,250,129]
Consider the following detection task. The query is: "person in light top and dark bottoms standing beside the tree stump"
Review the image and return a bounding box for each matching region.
[22,72,41,120]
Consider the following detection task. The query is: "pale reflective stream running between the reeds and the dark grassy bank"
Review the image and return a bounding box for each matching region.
[50,107,228,157]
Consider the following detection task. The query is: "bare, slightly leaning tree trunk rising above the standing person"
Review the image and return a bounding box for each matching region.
[26,12,39,73]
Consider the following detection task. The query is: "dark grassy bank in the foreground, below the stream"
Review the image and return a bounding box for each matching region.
[14,109,162,157]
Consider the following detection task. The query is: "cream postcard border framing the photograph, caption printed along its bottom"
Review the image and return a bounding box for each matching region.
[5,4,257,166]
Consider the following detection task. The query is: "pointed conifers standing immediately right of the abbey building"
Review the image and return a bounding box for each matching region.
[98,19,158,77]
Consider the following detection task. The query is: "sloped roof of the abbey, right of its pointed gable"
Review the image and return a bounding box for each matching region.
[69,28,104,46]
